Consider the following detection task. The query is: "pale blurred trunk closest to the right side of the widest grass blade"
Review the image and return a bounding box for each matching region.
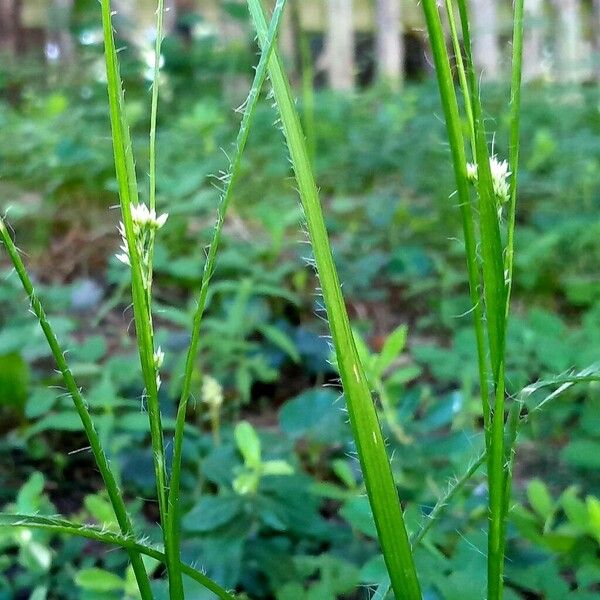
[327,0,354,91]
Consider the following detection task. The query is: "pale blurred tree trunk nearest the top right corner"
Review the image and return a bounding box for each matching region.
[554,0,585,83]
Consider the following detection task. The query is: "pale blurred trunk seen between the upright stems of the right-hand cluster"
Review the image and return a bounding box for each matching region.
[471,0,500,81]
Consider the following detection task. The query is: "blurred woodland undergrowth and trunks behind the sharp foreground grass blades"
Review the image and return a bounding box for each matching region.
[0,0,600,600]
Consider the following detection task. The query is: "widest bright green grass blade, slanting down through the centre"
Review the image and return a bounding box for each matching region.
[248,0,421,600]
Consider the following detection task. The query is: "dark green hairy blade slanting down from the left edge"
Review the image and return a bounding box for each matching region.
[0,217,152,600]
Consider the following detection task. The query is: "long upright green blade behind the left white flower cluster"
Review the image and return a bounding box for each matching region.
[101,0,178,600]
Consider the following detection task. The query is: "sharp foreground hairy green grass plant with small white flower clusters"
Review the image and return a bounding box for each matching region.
[0,0,598,600]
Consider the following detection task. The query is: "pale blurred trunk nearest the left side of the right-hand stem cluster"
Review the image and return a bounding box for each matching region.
[375,0,404,89]
